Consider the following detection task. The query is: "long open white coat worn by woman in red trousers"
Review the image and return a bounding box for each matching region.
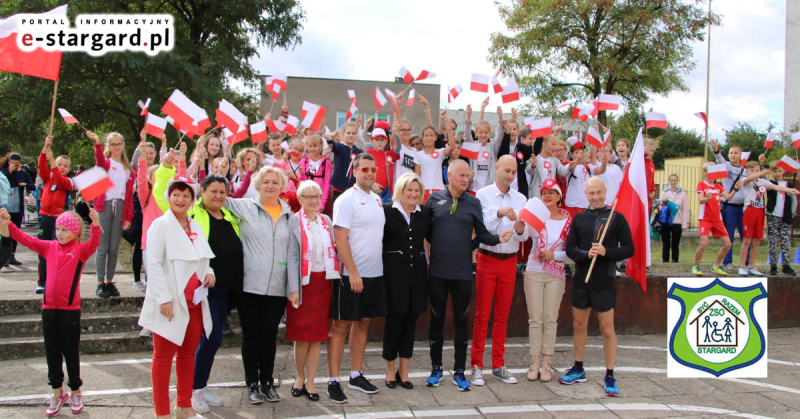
[139,210,214,346]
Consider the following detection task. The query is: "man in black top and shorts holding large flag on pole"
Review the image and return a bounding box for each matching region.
[558,176,634,397]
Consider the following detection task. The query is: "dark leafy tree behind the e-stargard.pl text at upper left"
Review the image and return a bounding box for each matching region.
[0,0,305,165]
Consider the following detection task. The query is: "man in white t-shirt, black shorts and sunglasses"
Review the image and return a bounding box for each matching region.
[328,153,387,403]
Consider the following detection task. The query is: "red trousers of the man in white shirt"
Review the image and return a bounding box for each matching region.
[471,253,517,369]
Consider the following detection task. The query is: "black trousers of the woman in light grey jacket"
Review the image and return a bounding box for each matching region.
[238,292,286,386]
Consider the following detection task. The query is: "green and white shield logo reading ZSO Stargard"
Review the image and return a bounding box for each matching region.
[667,278,767,378]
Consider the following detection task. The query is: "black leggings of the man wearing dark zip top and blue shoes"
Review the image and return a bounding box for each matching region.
[428,277,472,370]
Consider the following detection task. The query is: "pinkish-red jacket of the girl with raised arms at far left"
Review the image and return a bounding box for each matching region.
[8,223,100,310]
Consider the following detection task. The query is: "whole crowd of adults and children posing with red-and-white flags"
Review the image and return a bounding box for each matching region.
[0,93,797,418]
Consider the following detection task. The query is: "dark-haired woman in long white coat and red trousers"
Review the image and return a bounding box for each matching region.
[139,176,214,419]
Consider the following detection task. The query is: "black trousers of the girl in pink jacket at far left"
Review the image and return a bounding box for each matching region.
[42,309,83,391]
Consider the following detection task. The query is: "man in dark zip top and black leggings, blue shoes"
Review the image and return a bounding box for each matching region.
[426,160,514,390]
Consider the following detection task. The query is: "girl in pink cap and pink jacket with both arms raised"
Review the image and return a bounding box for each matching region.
[0,209,100,416]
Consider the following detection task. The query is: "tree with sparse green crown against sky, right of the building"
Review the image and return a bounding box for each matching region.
[489,0,719,124]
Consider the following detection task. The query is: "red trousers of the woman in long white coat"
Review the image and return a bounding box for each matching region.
[152,307,203,416]
